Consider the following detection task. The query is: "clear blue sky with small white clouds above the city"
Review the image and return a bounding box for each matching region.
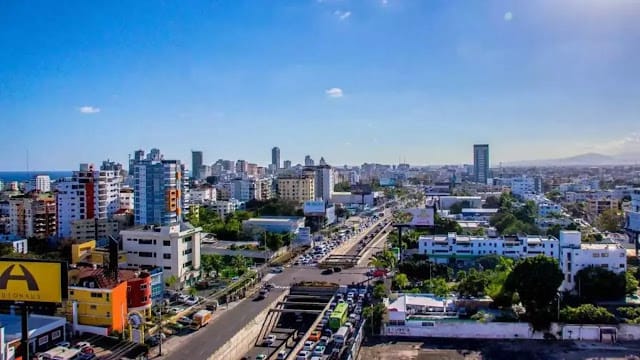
[0,0,640,170]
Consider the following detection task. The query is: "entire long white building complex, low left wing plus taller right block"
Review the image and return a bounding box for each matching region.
[418,231,627,291]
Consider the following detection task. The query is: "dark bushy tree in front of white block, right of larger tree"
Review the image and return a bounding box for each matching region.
[575,266,626,302]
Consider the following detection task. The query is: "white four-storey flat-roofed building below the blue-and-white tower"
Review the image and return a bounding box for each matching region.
[120,223,202,286]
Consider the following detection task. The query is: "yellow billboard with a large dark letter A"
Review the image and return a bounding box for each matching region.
[0,259,67,303]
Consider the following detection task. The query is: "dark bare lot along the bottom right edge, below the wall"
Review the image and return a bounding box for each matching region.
[358,339,640,360]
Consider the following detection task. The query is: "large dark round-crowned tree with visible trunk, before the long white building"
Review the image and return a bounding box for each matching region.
[504,255,563,329]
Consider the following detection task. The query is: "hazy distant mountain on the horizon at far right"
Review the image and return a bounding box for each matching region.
[503,153,640,166]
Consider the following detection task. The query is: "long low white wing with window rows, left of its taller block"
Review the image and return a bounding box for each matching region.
[418,233,560,264]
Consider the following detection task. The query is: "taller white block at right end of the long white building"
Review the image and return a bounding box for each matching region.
[560,231,627,291]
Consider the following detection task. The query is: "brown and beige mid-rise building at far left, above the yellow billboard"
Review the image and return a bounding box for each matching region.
[9,195,58,239]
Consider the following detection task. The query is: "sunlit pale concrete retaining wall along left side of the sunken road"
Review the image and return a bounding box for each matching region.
[209,292,288,360]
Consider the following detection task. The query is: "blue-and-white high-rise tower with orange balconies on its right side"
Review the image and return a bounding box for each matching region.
[133,150,183,225]
